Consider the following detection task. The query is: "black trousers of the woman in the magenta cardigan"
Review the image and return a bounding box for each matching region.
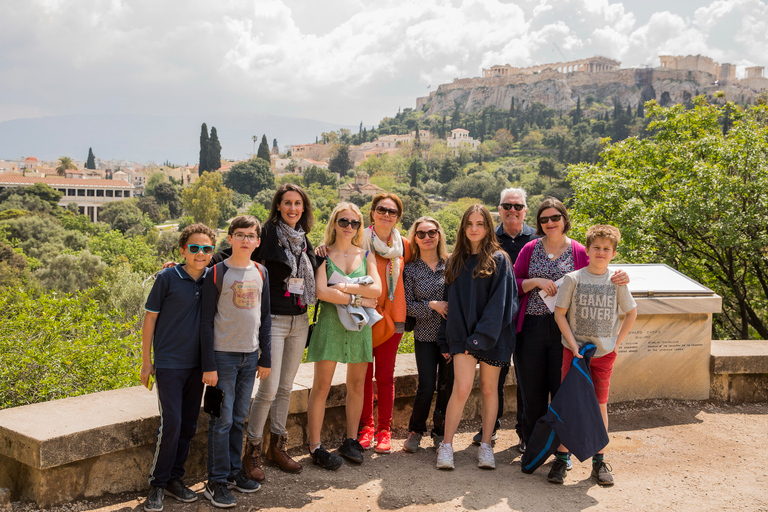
[515,314,563,443]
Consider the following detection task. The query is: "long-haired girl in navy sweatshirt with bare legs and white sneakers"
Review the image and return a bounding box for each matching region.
[437,204,518,469]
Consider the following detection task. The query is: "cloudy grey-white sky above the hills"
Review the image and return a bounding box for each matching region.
[0,0,768,125]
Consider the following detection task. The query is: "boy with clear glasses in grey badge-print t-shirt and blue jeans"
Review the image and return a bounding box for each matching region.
[200,215,272,508]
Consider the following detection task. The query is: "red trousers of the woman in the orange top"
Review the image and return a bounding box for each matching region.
[360,333,403,432]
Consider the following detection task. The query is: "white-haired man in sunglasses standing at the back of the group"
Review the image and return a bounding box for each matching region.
[472,188,539,452]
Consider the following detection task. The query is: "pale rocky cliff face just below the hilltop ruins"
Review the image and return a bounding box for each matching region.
[416,68,768,115]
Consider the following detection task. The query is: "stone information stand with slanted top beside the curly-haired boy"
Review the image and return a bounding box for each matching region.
[610,264,722,402]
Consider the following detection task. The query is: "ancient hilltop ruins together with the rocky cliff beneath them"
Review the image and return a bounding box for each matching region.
[416,55,768,115]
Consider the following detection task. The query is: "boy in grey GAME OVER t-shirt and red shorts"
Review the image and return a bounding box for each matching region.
[547,224,637,486]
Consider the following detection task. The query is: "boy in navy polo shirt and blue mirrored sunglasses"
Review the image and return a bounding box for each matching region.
[141,224,216,512]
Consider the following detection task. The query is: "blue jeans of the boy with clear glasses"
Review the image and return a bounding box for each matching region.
[208,350,259,482]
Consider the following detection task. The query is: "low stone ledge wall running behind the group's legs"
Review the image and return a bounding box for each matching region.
[0,341,768,507]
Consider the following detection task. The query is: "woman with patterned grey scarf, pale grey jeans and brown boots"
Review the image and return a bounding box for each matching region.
[243,183,318,481]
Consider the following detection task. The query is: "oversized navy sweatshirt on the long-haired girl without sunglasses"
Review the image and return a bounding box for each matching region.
[437,251,518,363]
